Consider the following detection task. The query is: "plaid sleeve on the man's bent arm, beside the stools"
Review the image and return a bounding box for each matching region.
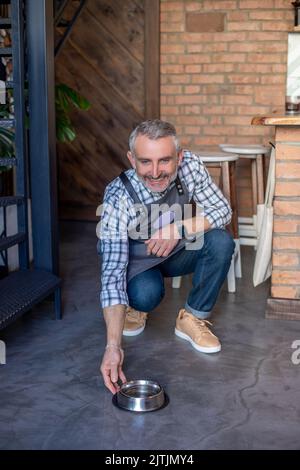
[193,157,232,228]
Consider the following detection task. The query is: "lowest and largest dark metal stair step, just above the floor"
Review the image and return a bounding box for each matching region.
[0,270,61,329]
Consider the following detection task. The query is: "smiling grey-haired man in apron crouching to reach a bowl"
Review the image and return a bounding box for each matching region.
[99,119,234,393]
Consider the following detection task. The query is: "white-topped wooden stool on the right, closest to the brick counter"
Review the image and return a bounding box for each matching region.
[220,144,271,246]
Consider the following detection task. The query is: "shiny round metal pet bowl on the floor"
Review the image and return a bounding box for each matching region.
[112,380,169,412]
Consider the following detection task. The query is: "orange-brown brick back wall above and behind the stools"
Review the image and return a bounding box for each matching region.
[161,0,294,216]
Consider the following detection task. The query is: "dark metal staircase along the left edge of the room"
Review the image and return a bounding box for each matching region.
[0,0,61,329]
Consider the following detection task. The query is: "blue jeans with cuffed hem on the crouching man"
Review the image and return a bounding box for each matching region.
[127,229,235,319]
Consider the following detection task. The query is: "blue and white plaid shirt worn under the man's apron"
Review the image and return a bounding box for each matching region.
[98,150,232,308]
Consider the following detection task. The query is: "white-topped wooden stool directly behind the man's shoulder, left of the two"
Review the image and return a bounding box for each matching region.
[172,151,242,292]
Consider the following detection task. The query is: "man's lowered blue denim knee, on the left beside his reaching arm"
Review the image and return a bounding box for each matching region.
[127,276,165,312]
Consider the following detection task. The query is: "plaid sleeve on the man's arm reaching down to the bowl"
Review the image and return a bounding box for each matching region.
[97,185,128,308]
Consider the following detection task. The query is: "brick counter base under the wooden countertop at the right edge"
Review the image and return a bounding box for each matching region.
[271,127,300,299]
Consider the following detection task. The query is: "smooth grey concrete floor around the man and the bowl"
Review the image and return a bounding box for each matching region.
[0,222,300,450]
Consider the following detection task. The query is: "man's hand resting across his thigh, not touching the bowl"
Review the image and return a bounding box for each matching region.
[145,224,180,257]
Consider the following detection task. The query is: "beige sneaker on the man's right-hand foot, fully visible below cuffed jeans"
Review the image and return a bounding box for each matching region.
[175,308,221,353]
